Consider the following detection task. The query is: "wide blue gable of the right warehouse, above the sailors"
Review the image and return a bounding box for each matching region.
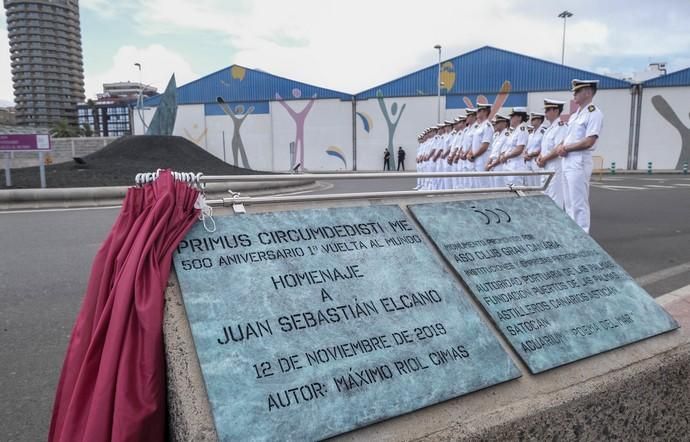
[356,46,630,99]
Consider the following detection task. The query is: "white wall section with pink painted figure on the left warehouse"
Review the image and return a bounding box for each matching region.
[270,99,352,171]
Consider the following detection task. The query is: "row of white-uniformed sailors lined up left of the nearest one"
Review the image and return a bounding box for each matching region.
[416,99,567,207]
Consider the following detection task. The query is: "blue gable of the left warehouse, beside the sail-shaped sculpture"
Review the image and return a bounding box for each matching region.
[144,64,352,106]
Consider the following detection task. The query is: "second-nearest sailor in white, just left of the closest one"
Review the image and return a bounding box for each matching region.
[535,99,568,209]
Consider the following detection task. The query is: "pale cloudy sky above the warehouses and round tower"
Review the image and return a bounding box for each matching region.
[0,0,690,104]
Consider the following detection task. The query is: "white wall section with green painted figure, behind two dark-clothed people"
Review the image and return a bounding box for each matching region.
[357,97,438,170]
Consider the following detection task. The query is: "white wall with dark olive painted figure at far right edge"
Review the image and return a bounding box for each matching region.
[637,87,690,169]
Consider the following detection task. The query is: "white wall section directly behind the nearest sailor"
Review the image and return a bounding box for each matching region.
[527,89,631,169]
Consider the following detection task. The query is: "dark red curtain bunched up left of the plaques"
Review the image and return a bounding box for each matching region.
[49,171,199,442]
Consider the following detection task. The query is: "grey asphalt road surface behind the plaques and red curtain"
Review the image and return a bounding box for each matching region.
[0,175,690,441]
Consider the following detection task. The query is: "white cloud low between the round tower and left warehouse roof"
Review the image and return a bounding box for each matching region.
[86,45,199,98]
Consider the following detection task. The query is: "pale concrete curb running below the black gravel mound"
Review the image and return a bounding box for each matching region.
[0,180,316,210]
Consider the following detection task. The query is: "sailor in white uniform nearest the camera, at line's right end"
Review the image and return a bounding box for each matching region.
[557,79,604,233]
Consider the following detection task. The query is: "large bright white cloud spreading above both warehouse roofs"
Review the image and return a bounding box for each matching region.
[107,0,639,92]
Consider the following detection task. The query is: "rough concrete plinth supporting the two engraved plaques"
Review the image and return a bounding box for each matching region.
[164,201,690,441]
